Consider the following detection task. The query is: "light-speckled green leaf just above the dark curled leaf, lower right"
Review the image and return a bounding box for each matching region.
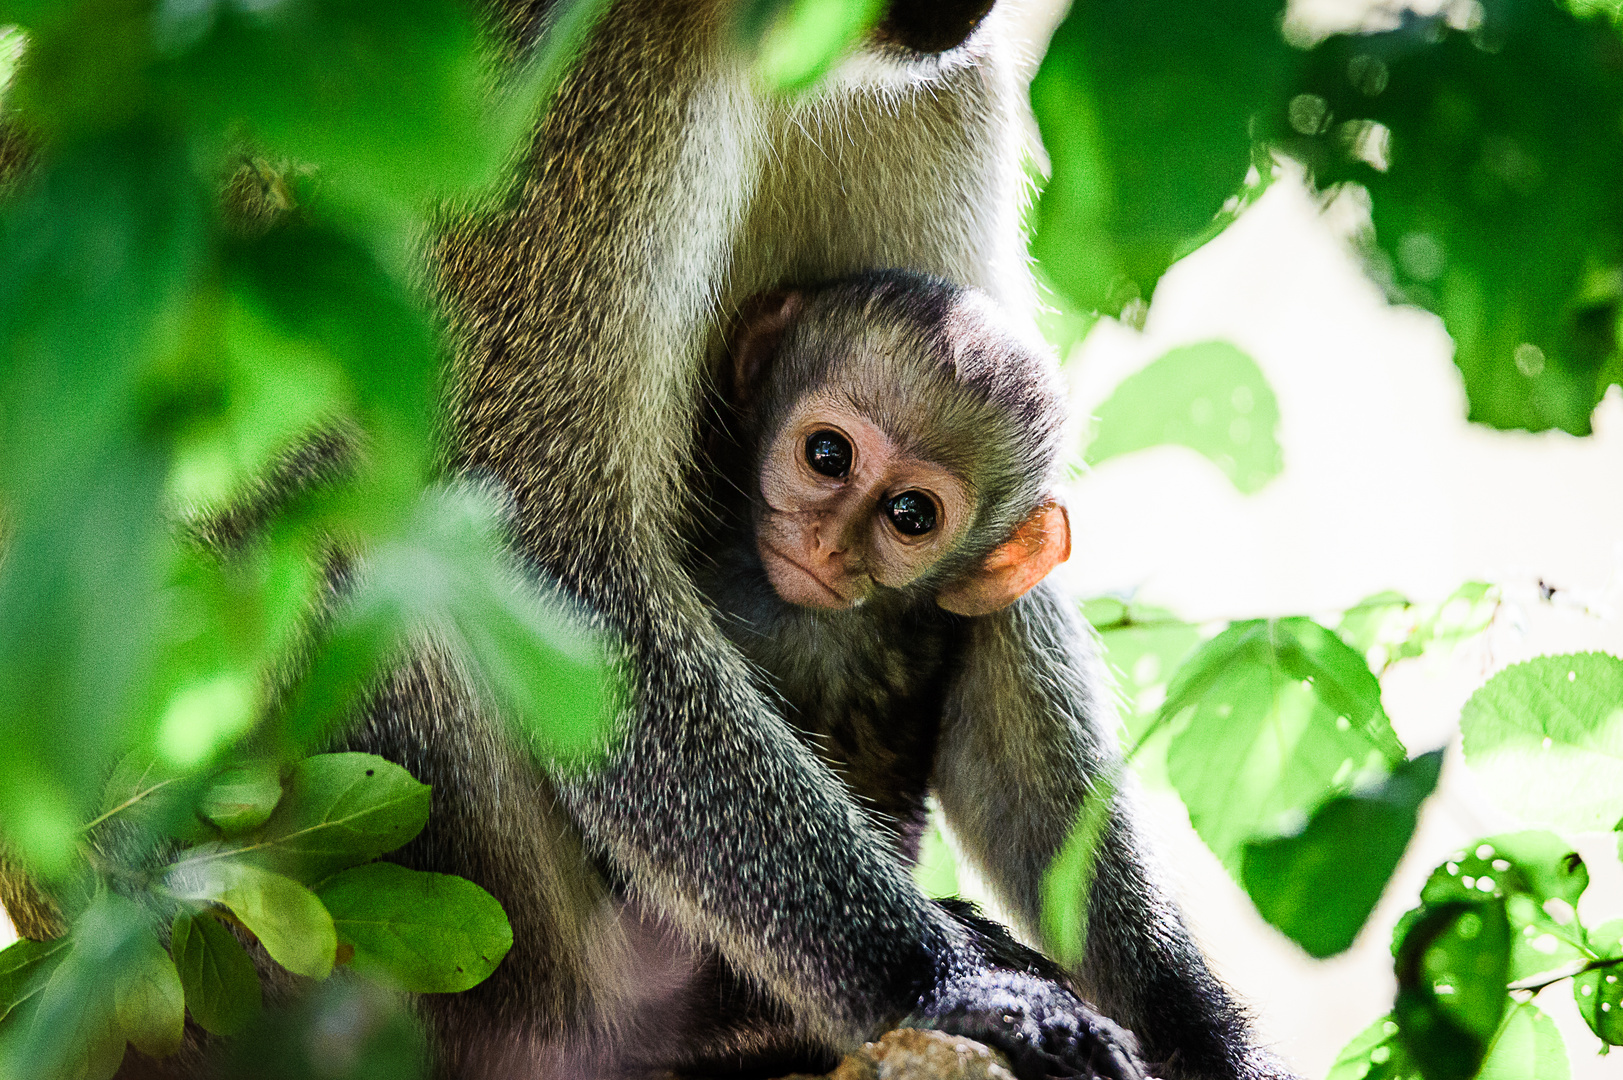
[1420,832,1589,979]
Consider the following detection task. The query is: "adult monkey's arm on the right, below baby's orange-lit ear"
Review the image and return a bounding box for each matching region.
[936,583,1289,1080]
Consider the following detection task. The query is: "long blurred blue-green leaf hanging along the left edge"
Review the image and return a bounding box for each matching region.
[0,132,204,874]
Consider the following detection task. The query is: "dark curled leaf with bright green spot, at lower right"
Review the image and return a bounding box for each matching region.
[1393,898,1511,1080]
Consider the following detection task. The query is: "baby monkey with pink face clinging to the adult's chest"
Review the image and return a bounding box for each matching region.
[695,271,1071,864]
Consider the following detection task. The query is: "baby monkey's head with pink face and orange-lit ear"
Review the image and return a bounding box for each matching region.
[724,271,1071,616]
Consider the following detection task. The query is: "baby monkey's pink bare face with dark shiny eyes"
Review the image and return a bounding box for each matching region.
[755,393,975,609]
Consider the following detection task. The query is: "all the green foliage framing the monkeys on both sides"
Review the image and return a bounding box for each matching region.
[0,0,1623,1080]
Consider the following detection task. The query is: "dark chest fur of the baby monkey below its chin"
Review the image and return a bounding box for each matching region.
[696,552,959,862]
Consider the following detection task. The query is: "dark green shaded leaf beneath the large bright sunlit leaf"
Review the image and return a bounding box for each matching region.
[1240,750,1443,958]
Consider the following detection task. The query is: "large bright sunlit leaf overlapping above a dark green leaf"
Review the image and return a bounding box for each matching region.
[1160,619,1407,879]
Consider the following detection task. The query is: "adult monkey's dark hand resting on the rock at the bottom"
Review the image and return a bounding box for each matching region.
[904,970,1146,1080]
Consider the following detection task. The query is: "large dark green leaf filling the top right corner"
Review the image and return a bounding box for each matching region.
[1274,0,1623,435]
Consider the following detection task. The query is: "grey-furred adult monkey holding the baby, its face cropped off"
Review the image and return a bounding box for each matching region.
[196,0,1277,1078]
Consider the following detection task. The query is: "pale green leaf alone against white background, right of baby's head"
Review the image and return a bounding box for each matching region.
[1084,341,1284,495]
